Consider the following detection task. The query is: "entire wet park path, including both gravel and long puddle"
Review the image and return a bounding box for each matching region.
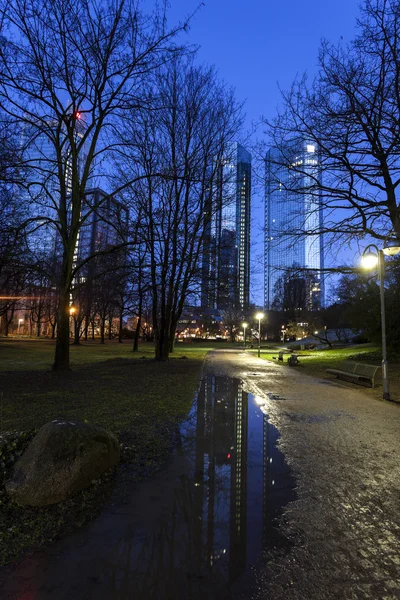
[0,351,400,600]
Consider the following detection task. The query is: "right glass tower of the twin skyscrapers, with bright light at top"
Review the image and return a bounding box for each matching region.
[264,138,324,310]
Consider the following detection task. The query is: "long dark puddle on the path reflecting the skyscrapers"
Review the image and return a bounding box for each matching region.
[5,376,295,600]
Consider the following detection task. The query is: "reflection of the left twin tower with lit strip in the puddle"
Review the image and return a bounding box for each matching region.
[195,376,248,582]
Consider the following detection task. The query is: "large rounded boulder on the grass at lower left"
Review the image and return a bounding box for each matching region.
[6,420,120,506]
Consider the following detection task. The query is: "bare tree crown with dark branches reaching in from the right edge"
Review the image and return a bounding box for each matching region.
[267,0,400,253]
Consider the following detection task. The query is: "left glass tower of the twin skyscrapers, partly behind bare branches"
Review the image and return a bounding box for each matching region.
[201,142,251,310]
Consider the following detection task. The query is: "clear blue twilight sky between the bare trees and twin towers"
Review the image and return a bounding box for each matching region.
[169,0,359,304]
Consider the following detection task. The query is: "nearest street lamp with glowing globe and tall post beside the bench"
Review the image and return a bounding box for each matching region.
[361,239,400,400]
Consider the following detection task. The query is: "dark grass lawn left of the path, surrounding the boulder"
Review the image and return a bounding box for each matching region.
[0,339,217,564]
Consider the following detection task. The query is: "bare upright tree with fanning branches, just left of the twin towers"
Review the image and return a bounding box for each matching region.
[118,58,241,360]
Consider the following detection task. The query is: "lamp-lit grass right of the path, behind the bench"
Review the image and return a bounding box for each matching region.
[247,344,400,401]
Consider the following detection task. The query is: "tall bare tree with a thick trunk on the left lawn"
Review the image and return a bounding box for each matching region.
[0,0,189,371]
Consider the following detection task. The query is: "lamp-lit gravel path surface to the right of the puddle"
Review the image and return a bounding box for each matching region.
[206,351,400,600]
